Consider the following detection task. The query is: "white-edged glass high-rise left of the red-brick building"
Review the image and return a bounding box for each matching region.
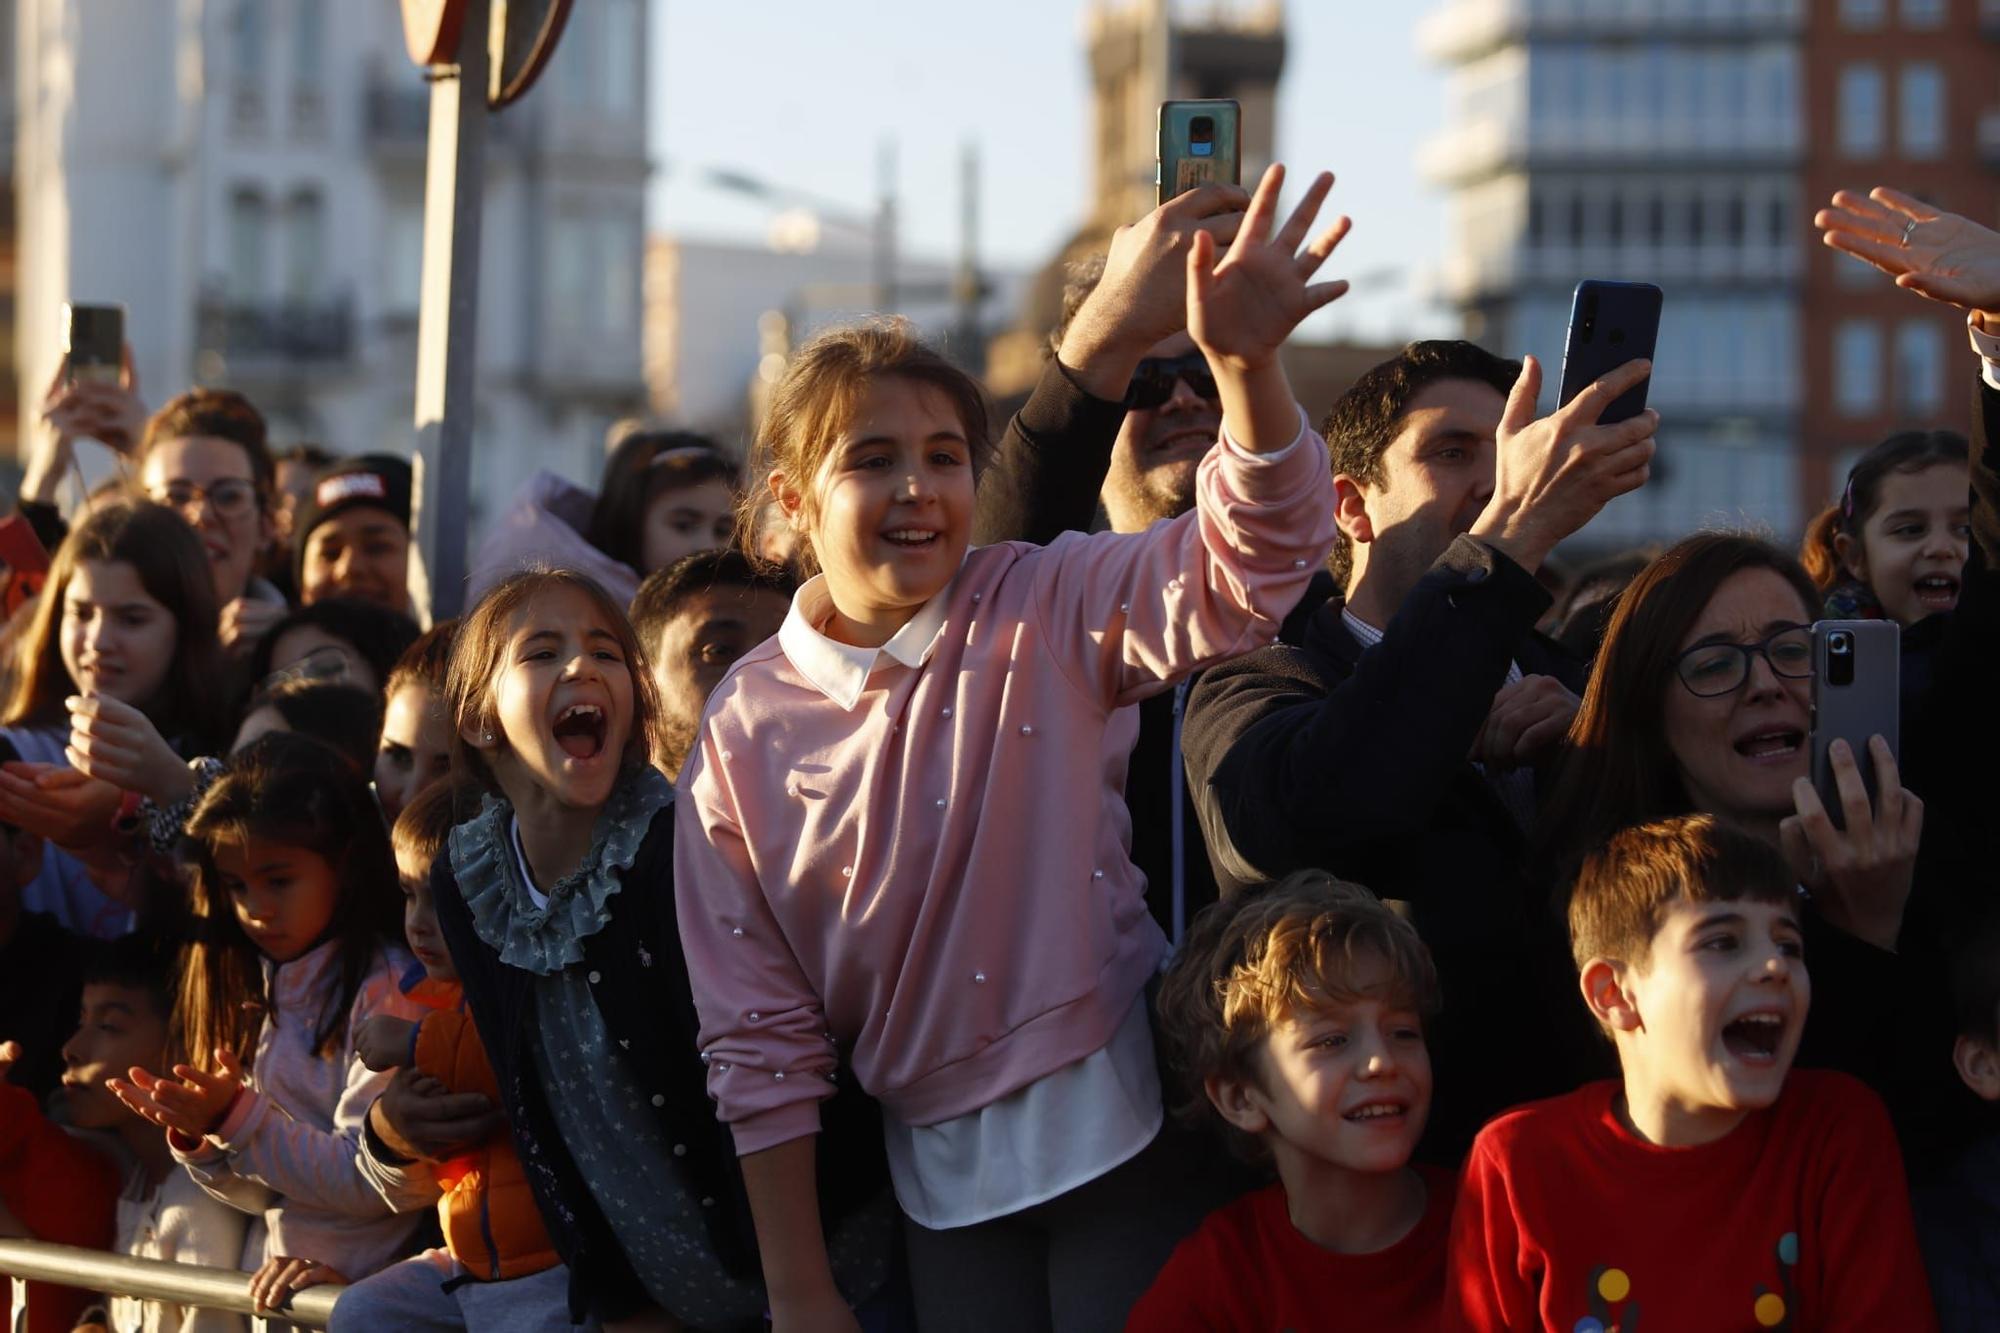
[1420,0,1810,546]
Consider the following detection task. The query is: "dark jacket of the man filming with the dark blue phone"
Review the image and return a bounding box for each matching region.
[1182,536,1600,1159]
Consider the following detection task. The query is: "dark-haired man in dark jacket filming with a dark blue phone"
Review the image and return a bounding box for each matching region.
[1182,342,1658,1157]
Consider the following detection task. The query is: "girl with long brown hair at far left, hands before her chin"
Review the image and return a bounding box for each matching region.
[0,500,224,939]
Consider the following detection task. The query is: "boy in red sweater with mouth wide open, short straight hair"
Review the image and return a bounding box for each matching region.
[1444,817,1936,1333]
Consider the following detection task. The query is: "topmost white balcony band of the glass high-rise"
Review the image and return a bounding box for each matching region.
[1416,0,1816,64]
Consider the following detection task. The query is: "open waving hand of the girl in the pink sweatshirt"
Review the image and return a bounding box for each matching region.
[1188,164,1352,372]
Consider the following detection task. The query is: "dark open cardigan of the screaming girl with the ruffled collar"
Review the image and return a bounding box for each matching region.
[430,805,888,1319]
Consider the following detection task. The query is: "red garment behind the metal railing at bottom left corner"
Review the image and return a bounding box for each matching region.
[0,1083,118,1333]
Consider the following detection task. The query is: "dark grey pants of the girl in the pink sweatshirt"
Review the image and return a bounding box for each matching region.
[904,1129,1228,1333]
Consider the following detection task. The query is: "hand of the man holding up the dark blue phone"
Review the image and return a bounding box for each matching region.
[1472,356,1660,570]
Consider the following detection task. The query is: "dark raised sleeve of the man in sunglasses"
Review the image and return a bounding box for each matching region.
[972,356,1124,546]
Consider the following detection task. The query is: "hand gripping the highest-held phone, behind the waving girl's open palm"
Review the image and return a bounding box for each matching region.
[1056,184,1250,400]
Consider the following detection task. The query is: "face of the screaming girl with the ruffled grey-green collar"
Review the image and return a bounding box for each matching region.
[482,586,634,809]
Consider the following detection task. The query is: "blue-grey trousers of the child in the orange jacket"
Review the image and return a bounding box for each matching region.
[326,1249,596,1333]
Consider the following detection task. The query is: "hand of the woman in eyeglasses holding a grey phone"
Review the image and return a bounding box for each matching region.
[1778,737,1924,953]
